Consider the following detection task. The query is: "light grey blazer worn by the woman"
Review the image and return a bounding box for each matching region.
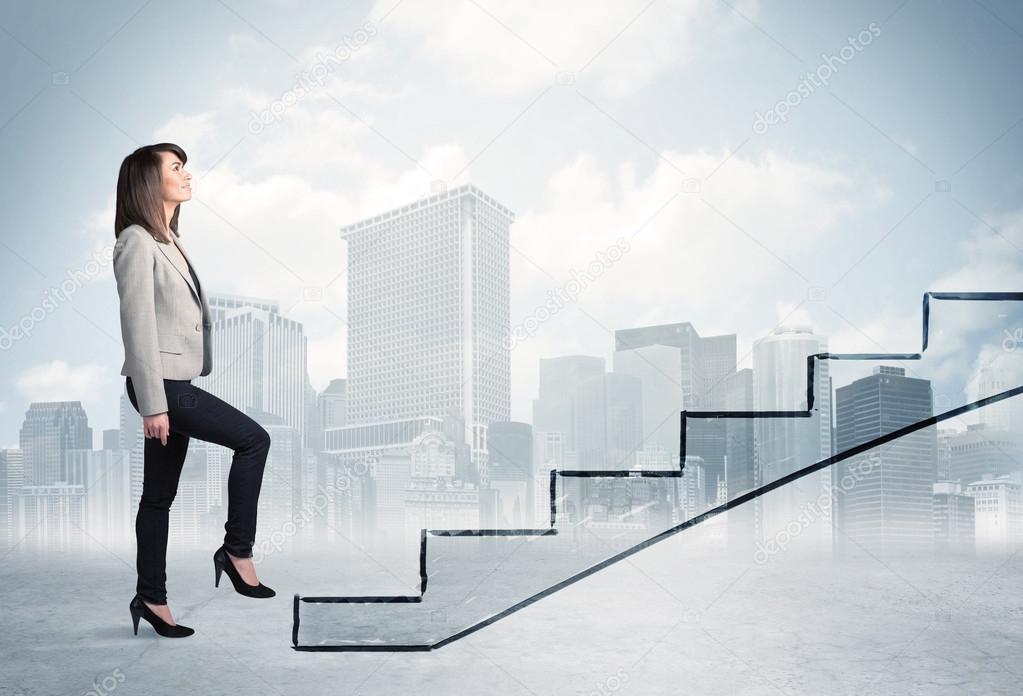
[114,225,213,416]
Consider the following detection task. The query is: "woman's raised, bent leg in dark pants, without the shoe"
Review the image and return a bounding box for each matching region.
[158,381,270,558]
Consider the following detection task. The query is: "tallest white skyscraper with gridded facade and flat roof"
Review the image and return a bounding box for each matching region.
[341,185,515,485]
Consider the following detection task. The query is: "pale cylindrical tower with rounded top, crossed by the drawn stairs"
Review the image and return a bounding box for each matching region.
[753,325,832,551]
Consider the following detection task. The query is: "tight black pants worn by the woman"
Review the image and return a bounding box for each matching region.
[125,377,270,604]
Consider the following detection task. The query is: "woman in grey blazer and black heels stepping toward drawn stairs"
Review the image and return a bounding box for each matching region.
[114,142,275,638]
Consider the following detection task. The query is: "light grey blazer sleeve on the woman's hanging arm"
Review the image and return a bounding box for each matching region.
[114,226,167,417]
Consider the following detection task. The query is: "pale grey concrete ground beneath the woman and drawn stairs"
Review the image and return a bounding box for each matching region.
[0,536,1023,696]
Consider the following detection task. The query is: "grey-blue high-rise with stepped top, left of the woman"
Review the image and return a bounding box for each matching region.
[18,401,92,485]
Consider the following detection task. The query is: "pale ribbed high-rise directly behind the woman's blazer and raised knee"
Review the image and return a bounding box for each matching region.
[193,296,308,433]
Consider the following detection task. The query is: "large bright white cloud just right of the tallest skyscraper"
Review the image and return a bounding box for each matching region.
[513,150,873,313]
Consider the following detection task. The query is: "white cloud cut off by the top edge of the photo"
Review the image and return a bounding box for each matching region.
[369,0,758,97]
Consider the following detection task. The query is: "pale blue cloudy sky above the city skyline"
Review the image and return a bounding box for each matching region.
[0,0,1023,446]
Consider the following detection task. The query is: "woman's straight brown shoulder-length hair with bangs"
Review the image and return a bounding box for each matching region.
[114,142,188,244]
